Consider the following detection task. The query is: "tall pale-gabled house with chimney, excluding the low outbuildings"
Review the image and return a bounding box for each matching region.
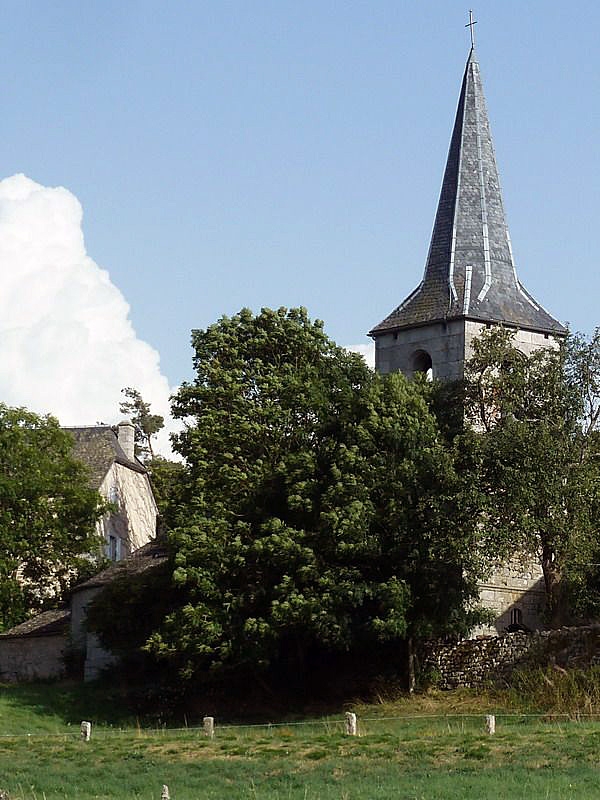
[65,420,158,561]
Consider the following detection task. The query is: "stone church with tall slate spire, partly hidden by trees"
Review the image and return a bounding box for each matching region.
[369,34,567,632]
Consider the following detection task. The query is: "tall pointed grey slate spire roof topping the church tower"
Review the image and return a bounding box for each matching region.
[370,48,566,336]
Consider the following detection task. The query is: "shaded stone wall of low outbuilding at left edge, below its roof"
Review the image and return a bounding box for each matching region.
[0,633,67,683]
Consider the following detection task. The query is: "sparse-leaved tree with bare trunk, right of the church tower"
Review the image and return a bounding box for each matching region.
[465,329,600,625]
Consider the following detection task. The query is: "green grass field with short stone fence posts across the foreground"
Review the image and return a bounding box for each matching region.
[0,686,600,800]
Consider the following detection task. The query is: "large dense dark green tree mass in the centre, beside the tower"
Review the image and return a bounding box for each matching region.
[150,309,476,674]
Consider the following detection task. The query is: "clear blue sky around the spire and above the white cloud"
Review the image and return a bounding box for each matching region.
[0,0,600,385]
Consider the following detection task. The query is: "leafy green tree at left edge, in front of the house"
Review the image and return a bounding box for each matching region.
[0,405,104,629]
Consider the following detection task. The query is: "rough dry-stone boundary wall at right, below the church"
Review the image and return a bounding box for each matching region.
[421,623,600,689]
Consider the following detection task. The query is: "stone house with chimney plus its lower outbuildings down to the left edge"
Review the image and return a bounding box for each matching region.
[0,421,164,681]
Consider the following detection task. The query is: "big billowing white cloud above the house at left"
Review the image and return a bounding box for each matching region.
[0,175,172,454]
